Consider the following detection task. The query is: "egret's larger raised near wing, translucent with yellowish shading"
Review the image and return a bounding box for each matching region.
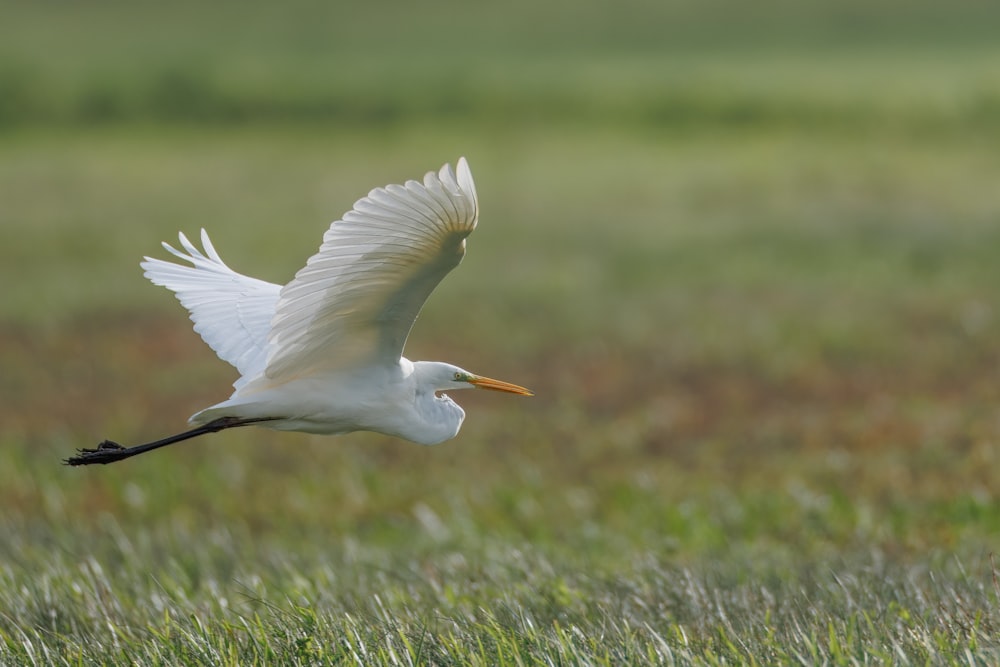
[265,158,478,381]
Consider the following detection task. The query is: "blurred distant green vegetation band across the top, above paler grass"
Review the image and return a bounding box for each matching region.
[0,0,1000,134]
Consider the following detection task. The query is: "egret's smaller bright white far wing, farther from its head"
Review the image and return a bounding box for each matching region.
[140,229,281,389]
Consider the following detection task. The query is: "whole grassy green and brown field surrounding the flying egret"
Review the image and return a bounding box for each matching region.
[0,0,1000,665]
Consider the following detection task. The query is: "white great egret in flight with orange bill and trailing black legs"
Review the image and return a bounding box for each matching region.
[66,158,532,466]
